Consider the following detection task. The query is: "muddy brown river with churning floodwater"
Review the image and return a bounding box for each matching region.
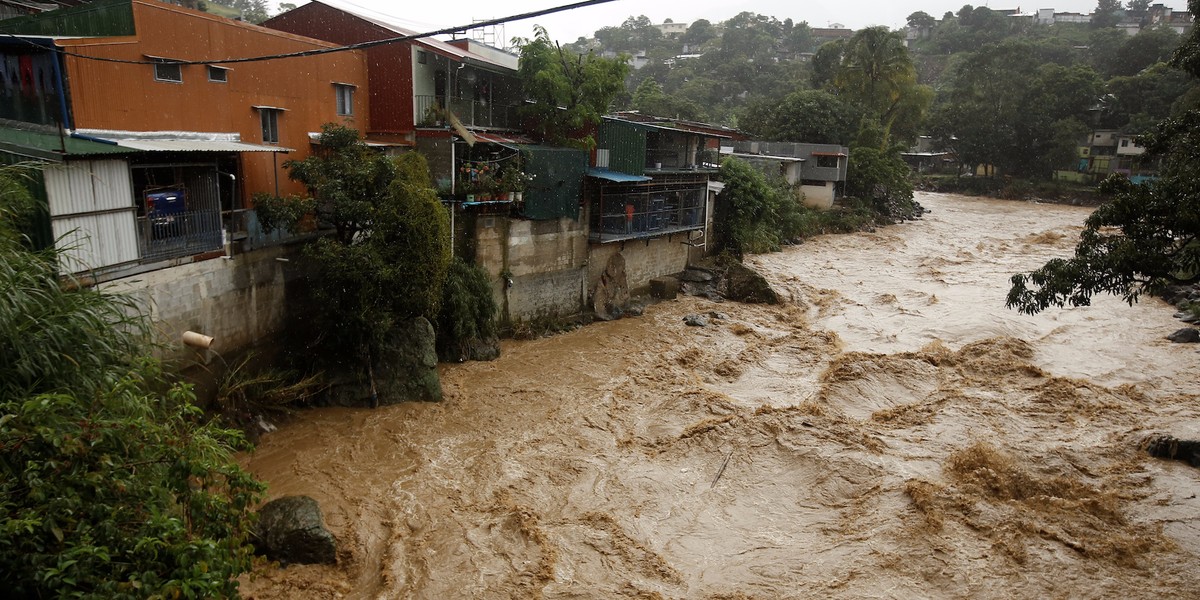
[242,194,1200,600]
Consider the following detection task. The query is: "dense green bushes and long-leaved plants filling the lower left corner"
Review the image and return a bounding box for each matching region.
[0,165,263,599]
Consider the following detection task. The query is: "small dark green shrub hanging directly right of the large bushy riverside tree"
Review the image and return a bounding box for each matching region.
[438,258,497,356]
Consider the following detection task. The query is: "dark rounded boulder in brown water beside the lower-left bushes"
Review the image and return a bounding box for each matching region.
[253,496,337,564]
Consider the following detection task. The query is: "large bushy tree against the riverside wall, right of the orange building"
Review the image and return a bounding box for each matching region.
[254,124,450,377]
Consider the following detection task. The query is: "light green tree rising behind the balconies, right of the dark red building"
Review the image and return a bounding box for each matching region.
[518,26,629,148]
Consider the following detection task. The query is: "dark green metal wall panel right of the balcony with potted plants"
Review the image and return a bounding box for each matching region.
[521,145,588,220]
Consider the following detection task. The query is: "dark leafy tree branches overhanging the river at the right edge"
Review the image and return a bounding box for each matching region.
[1007,0,1200,313]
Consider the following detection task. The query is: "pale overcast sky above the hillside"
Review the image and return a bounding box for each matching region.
[274,0,1187,47]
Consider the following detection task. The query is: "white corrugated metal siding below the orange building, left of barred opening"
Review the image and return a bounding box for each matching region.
[44,161,138,271]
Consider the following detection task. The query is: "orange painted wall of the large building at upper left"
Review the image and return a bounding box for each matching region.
[59,0,370,204]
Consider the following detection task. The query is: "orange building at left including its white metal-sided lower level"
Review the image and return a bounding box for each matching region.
[0,0,368,272]
